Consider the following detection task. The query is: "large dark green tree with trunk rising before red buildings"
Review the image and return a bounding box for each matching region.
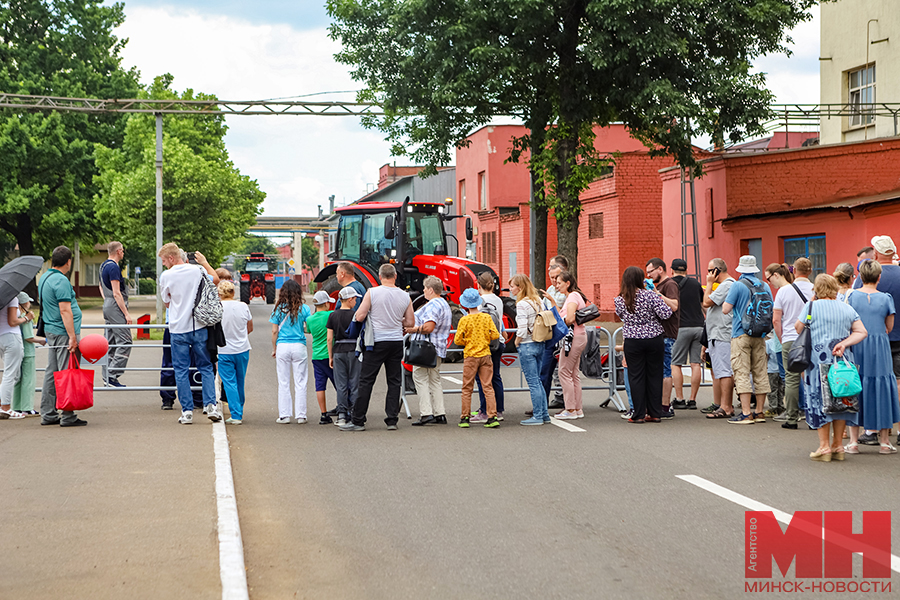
[327,0,816,270]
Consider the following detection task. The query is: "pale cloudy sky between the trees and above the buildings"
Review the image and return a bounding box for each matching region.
[109,0,819,216]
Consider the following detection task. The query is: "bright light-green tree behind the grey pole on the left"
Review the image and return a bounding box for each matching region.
[95,75,265,265]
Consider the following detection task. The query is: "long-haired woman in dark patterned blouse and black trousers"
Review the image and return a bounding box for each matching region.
[615,267,672,423]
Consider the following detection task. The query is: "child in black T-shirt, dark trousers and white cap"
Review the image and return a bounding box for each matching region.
[325,286,361,426]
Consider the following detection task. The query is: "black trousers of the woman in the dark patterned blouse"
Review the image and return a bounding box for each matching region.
[625,336,665,419]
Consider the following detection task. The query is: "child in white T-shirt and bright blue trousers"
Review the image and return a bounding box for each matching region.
[219,280,253,425]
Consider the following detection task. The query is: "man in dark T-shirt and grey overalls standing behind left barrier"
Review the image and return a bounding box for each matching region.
[99,242,132,387]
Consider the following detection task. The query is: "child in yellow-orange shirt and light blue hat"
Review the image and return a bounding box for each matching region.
[453,288,500,427]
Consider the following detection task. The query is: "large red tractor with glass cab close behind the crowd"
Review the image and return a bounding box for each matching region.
[315,197,516,359]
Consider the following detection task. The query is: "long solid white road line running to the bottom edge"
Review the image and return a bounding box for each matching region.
[212,421,250,600]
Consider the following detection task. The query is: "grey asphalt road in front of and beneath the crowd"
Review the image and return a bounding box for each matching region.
[0,304,900,599]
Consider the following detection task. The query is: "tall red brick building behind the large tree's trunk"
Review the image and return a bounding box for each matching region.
[456,125,672,318]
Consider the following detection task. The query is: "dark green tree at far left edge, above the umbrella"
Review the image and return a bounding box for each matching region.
[0,0,138,256]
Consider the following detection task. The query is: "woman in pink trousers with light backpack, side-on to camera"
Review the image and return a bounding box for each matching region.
[546,271,587,419]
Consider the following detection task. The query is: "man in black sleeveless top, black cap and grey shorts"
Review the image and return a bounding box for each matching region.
[672,258,706,410]
